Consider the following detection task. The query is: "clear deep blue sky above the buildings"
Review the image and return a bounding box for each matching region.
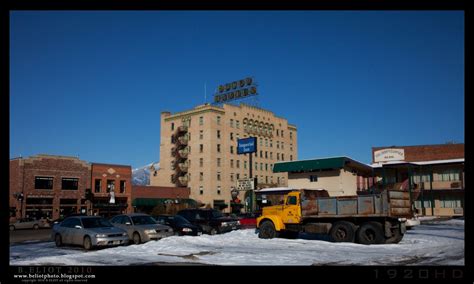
[10,11,465,168]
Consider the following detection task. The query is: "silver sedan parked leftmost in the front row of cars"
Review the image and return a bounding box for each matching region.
[51,216,128,250]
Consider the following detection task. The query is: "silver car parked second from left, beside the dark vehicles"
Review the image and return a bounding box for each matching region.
[110,213,174,244]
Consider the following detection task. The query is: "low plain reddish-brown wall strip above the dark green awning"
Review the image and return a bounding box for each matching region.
[132,185,191,199]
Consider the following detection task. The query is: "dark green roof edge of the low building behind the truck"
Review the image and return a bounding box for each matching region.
[273,157,372,173]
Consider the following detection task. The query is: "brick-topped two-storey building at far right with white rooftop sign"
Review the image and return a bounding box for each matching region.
[372,143,465,216]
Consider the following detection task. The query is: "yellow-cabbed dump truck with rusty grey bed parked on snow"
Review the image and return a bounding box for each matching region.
[257,189,413,244]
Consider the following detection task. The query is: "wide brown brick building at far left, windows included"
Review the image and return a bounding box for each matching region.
[10,155,90,219]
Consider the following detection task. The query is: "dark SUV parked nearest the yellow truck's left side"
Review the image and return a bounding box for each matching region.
[178,209,240,235]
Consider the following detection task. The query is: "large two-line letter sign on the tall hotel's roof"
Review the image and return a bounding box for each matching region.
[214,77,257,104]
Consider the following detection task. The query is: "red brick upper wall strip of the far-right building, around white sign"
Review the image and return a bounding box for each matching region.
[372,144,464,162]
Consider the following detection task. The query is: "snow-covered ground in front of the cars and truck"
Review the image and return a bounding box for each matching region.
[10,220,464,265]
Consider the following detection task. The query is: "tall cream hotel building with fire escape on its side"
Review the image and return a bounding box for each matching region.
[150,104,297,212]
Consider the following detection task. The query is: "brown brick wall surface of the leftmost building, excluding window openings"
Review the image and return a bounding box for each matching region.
[10,155,90,219]
